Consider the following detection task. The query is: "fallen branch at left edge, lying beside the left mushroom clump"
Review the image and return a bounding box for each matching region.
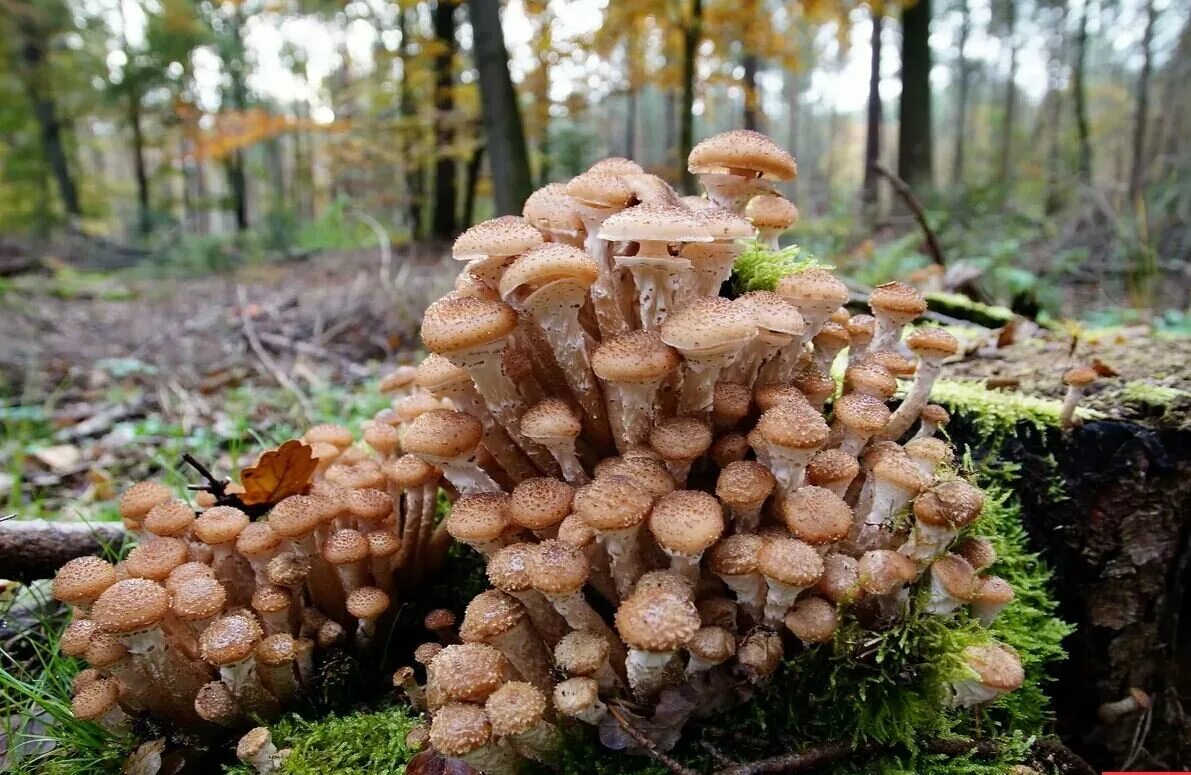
[0,519,127,582]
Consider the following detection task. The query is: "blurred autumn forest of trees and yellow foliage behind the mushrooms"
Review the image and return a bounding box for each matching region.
[0,0,1191,329]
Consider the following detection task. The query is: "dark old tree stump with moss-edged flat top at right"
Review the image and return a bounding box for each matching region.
[936,340,1191,770]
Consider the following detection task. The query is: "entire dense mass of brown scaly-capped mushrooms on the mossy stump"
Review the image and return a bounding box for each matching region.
[54,131,1100,775]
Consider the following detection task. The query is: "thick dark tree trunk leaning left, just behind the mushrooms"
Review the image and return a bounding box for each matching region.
[468,0,534,215]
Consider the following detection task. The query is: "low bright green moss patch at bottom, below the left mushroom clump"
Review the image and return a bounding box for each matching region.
[225,705,420,775]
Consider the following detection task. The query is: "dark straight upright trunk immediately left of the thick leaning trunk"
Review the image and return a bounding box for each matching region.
[431,0,457,239]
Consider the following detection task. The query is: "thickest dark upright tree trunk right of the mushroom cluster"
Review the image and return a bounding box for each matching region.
[897,0,934,195]
